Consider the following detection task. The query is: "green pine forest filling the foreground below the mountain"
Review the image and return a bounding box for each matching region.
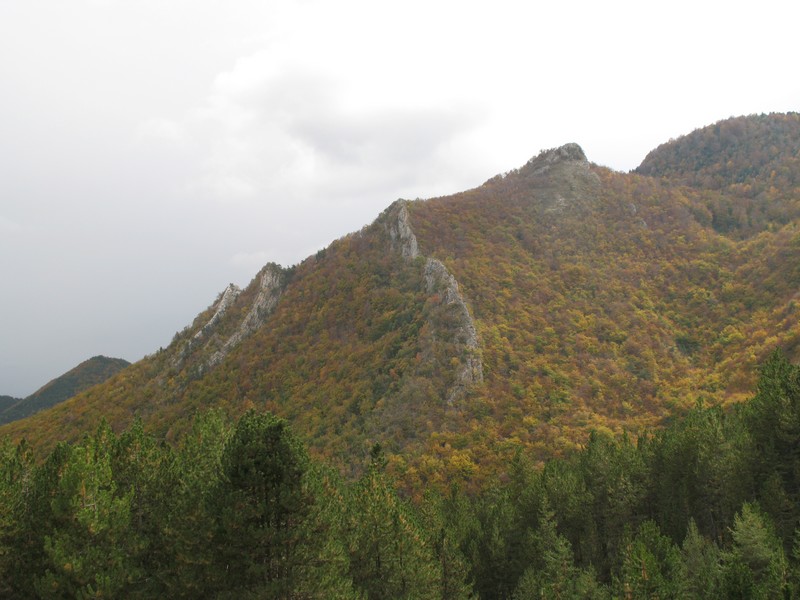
[0,353,800,600]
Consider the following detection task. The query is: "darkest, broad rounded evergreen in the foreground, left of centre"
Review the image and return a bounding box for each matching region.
[211,411,315,598]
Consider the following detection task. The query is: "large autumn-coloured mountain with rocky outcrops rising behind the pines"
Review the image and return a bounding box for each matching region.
[0,114,800,487]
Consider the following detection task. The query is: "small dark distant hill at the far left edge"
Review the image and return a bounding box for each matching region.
[0,356,130,424]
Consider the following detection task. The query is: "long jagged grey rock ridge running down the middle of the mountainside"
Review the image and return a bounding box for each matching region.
[380,200,484,405]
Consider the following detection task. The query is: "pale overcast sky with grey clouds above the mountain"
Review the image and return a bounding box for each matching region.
[0,0,800,397]
